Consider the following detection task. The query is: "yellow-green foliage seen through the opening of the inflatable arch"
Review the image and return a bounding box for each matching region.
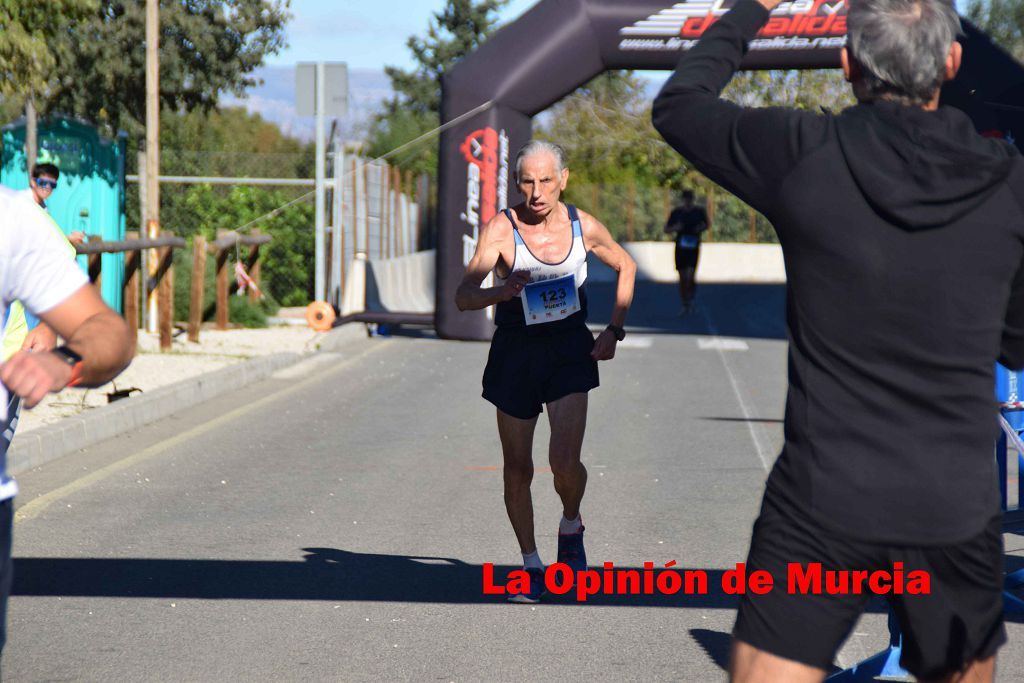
[537,66,853,241]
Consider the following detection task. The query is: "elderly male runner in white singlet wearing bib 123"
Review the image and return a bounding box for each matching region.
[456,140,636,602]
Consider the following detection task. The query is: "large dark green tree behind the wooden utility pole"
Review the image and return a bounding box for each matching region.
[46,0,290,132]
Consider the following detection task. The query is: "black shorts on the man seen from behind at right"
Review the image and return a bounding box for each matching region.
[733,496,1007,679]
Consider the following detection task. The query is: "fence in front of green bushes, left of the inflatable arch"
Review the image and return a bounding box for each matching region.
[126,150,434,326]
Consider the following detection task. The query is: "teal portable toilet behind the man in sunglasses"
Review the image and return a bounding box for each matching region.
[0,117,128,311]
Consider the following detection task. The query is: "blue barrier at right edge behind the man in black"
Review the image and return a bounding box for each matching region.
[826,365,1024,683]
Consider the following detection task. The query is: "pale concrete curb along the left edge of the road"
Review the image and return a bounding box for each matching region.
[7,325,367,475]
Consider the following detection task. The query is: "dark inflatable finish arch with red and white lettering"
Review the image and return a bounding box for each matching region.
[434,0,1024,340]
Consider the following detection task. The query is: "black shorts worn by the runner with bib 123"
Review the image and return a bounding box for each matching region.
[483,326,600,420]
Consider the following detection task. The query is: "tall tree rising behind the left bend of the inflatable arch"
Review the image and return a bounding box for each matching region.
[368,0,508,176]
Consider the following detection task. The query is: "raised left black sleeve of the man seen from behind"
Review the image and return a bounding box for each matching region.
[652,0,824,218]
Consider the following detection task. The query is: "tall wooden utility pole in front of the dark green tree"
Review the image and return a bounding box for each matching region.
[143,0,160,332]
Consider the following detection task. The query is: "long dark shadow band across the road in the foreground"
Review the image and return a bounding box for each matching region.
[12,548,937,618]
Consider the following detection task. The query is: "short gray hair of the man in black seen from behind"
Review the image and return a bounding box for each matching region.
[847,0,962,105]
